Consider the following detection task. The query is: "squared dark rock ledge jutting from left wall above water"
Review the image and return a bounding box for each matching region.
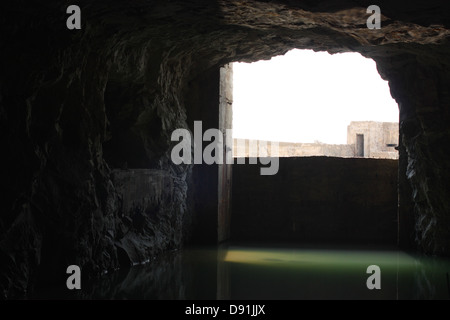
[109,169,187,266]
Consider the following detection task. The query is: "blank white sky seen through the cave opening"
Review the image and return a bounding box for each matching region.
[233,49,399,144]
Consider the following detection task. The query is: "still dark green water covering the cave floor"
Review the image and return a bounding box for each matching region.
[37,245,450,300]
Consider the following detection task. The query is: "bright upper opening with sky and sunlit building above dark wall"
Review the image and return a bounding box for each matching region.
[233,49,399,159]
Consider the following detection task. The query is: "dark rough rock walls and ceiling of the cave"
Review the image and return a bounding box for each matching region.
[0,0,450,297]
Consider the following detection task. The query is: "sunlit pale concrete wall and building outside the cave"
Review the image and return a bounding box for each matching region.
[233,121,398,159]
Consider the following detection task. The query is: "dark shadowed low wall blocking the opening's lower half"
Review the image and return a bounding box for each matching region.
[231,157,398,244]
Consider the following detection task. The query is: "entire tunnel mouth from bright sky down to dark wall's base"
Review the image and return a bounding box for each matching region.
[227,50,399,247]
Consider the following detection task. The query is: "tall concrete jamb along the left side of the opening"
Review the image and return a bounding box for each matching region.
[186,65,233,244]
